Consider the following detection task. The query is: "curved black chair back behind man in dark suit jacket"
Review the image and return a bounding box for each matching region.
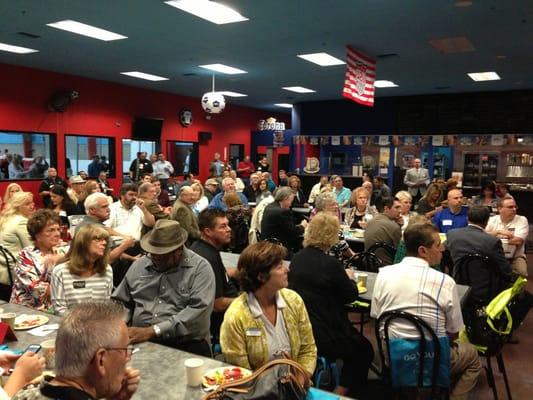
[452,253,500,304]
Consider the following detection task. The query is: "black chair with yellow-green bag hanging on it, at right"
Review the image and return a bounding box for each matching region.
[453,253,512,400]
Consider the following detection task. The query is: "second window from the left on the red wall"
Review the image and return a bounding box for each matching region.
[65,135,115,179]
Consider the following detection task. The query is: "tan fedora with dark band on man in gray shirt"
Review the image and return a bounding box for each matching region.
[141,219,188,254]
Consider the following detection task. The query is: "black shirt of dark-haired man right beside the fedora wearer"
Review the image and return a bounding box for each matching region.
[189,239,239,337]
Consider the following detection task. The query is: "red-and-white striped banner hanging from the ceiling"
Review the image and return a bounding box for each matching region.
[342,46,376,107]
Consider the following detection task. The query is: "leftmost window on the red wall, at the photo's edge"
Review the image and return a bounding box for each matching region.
[0,131,56,180]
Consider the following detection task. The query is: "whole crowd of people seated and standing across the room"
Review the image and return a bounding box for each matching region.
[0,153,528,399]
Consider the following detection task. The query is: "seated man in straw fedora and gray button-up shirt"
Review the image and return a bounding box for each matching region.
[112,219,215,357]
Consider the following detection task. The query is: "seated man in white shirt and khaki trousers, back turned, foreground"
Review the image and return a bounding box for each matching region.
[370,223,481,399]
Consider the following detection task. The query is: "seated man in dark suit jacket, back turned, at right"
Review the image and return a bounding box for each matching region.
[446,206,512,304]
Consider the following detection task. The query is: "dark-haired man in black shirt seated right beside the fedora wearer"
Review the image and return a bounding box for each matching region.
[191,208,239,338]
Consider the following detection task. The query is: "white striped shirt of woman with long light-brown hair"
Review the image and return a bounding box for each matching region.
[50,262,113,315]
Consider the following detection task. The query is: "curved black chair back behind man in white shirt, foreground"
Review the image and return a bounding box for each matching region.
[375,311,450,399]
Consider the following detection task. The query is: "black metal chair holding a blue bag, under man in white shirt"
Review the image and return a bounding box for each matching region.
[375,311,449,399]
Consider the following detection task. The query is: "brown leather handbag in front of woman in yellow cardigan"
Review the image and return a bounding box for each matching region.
[202,358,311,400]
